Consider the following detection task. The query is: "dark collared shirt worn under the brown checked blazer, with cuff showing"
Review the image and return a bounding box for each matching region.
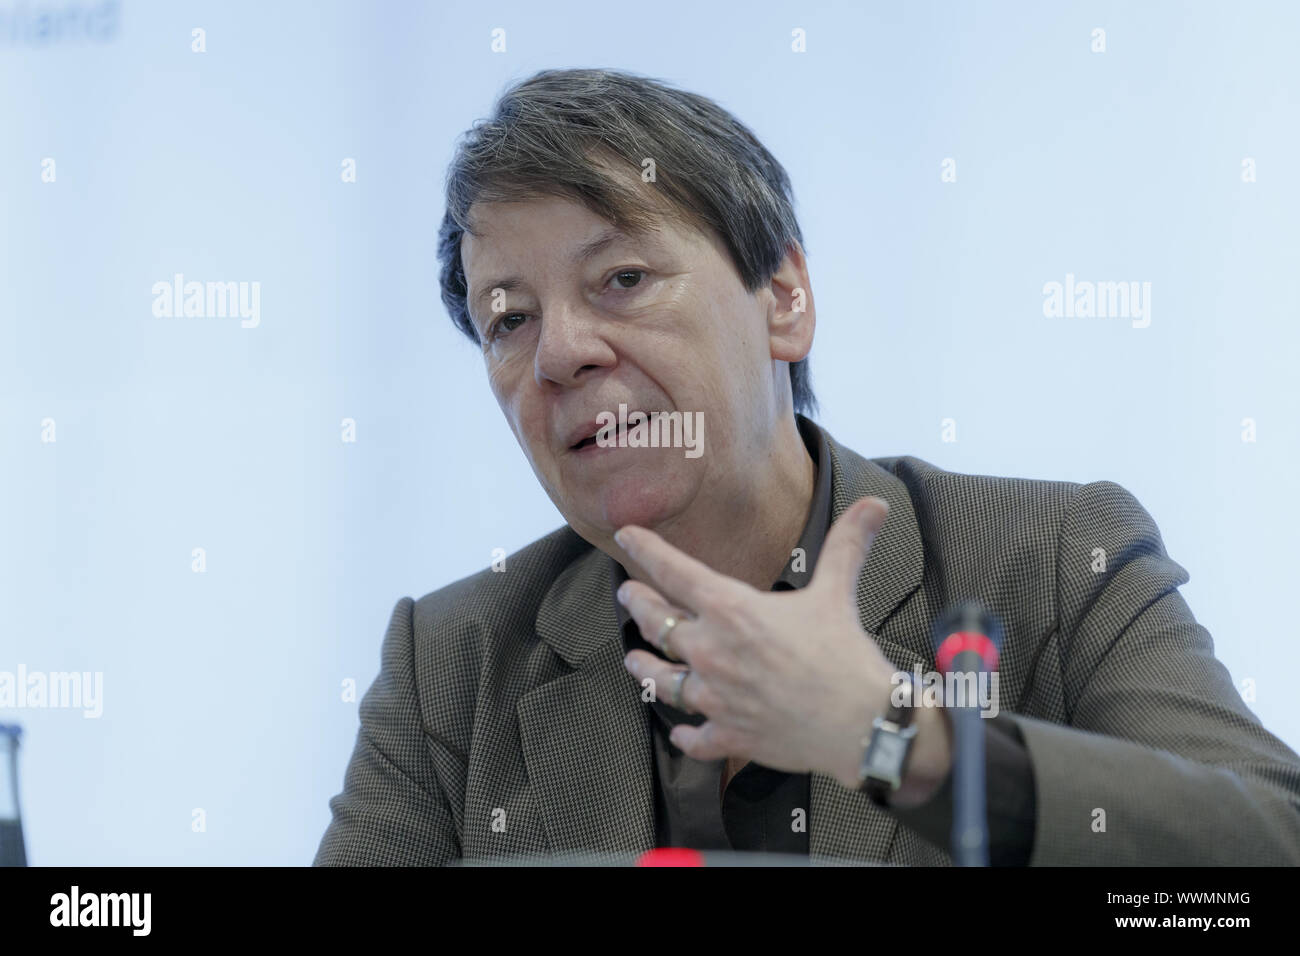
[611,415,1035,866]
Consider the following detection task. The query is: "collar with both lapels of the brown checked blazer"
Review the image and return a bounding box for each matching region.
[517,416,924,860]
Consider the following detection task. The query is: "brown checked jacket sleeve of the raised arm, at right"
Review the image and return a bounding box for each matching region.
[1008,481,1300,866]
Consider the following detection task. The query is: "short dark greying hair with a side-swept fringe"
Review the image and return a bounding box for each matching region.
[438,63,816,414]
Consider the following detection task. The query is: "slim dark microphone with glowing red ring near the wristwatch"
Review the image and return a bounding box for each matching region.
[933,601,1002,866]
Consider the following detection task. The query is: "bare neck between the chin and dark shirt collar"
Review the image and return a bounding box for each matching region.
[611,416,816,591]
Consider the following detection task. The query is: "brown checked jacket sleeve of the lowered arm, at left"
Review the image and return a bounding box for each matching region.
[312,597,460,866]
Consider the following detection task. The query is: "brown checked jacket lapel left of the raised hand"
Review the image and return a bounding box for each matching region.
[517,548,655,853]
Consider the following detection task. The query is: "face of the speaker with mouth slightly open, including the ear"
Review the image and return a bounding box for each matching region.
[460,184,811,546]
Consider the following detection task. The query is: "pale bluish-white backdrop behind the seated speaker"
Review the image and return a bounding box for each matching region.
[0,0,1300,865]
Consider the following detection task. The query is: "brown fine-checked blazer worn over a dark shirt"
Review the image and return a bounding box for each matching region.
[315,421,1300,865]
